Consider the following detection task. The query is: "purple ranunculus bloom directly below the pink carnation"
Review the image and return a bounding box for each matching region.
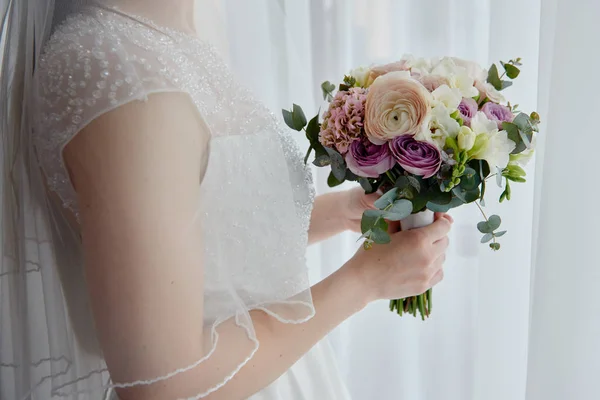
[346,139,396,178]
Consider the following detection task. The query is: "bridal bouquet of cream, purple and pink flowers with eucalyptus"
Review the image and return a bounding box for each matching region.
[283,57,540,319]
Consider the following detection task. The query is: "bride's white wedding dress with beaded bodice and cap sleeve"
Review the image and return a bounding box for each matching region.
[14,3,349,400]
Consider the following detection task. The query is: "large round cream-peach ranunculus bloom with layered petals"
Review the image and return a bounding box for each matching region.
[365,71,431,144]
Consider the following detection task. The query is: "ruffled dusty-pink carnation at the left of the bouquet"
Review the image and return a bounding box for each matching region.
[319,87,367,154]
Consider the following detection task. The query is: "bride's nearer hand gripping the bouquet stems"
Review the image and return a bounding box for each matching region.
[344,215,452,302]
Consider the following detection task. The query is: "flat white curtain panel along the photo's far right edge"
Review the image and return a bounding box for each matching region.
[527,0,600,400]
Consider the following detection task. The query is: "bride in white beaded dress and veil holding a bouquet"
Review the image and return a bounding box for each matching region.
[0,0,452,400]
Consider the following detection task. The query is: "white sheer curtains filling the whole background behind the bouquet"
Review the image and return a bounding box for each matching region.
[224,0,600,400]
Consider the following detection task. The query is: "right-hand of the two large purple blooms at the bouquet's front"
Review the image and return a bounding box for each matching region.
[390,135,442,178]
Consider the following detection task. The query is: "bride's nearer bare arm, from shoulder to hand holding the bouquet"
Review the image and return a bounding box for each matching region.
[65,94,450,400]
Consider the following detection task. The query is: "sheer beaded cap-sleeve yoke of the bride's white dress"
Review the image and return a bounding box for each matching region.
[35,8,313,228]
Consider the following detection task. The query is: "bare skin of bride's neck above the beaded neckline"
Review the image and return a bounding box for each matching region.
[107,0,196,33]
